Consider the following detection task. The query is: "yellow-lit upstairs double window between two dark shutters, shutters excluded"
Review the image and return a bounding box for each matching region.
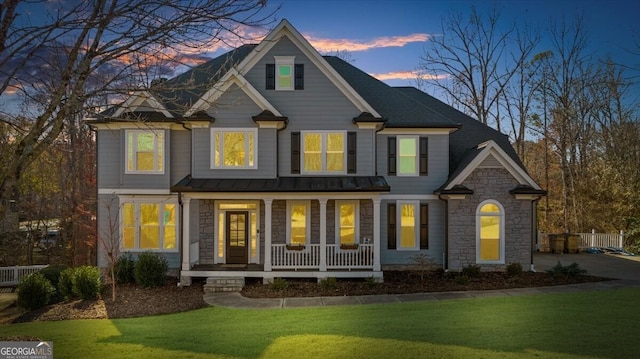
[302,132,346,173]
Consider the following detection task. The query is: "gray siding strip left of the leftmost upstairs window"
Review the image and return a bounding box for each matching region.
[96,130,124,188]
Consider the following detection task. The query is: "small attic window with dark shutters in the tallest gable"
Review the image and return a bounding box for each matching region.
[266,56,304,91]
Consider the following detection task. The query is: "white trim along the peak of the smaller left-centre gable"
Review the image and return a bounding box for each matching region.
[184,68,282,117]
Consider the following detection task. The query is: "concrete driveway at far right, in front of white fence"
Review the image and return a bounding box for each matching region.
[533,253,640,281]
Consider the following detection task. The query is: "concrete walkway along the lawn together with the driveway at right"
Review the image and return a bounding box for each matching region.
[204,253,640,309]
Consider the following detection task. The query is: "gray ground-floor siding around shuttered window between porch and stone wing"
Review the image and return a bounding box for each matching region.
[380,200,445,269]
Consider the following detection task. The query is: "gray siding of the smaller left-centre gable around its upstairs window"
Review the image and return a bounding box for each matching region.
[193,85,277,178]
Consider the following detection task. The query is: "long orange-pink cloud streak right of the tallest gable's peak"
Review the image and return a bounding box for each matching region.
[304,34,431,52]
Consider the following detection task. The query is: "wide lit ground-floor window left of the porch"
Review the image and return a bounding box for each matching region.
[121,202,178,251]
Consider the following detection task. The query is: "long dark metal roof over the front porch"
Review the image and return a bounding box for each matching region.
[171,176,391,192]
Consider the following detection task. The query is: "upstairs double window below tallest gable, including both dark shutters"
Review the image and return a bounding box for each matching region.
[291,131,357,174]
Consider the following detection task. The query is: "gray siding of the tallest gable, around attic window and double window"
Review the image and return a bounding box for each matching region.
[245,37,375,176]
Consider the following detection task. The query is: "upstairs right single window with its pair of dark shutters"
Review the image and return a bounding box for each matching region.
[387,136,429,176]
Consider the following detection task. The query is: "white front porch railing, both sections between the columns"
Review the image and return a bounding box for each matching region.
[271,244,374,269]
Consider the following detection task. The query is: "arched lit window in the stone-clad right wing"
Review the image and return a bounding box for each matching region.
[476,200,504,264]
